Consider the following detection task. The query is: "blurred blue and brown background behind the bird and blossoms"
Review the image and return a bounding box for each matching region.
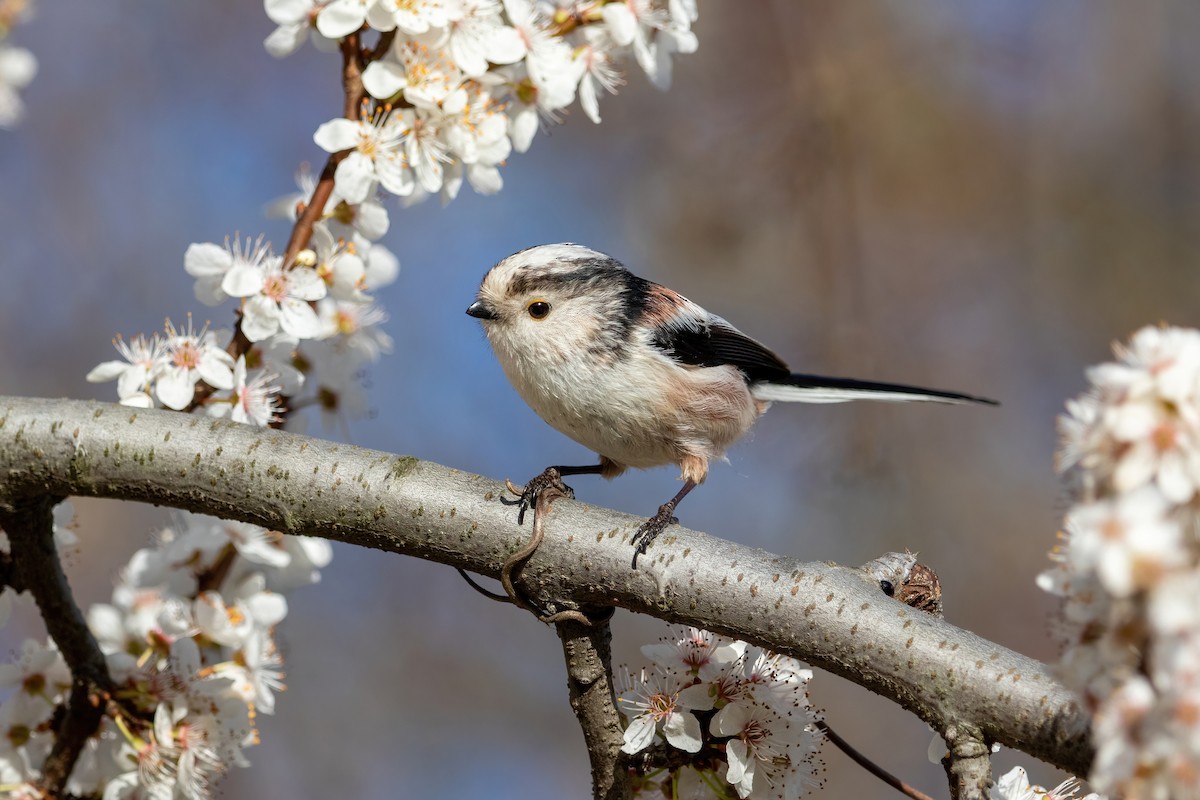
[0,0,1200,800]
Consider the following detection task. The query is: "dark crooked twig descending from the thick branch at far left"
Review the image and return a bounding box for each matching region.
[0,494,113,798]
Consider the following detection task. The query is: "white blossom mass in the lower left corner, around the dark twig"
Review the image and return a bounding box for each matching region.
[0,504,330,800]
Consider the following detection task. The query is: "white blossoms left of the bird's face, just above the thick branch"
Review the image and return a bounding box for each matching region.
[88,203,400,426]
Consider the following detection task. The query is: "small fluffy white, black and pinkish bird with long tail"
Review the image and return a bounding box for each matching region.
[467,243,995,569]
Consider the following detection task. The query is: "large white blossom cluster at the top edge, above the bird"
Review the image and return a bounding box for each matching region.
[264,0,697,209]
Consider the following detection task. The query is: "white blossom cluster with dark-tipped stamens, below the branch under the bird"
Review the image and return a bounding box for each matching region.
[618,628,821,800]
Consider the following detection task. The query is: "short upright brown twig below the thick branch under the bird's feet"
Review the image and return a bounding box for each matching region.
[552,609,632,800]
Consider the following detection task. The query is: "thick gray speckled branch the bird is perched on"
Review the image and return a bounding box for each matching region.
[0,398,1092,775]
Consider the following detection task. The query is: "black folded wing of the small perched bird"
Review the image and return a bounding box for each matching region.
[652,317,790,383]
